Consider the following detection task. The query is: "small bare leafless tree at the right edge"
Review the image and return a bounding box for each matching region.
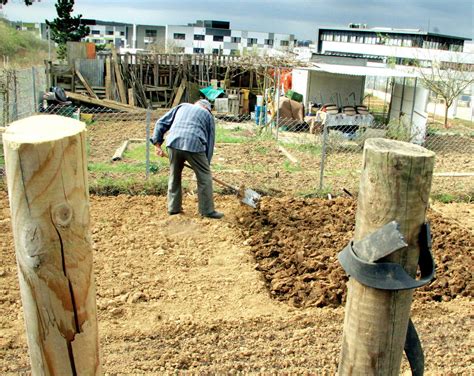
[418,61,474,128]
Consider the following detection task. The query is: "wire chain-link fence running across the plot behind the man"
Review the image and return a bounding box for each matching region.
[0,65,474,200]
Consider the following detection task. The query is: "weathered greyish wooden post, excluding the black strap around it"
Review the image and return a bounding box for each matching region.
[338,138,435,376]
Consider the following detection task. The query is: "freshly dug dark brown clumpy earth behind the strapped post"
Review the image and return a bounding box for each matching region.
[238,198,474,307]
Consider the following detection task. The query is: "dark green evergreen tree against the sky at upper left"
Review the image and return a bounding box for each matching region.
[46,0,90,60]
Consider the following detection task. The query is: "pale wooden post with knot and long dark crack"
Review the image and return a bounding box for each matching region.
[3,115,101,375]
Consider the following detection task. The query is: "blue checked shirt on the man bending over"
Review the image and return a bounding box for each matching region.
[150,103,215,163]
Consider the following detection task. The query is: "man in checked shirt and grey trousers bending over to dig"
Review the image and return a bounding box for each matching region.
[150,99,224,219]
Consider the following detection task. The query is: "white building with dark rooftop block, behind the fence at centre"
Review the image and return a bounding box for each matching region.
[166,20,296,55]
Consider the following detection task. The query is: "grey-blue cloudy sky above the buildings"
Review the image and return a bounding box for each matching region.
[1,0,474,40]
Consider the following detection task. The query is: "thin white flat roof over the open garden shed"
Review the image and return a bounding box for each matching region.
[298,64,416,77]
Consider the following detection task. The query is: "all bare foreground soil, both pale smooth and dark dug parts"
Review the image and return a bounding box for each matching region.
[0,192,474,375]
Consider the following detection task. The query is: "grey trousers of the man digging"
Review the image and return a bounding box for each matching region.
[168,148,214,215]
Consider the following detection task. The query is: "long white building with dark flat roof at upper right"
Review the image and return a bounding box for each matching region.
[317,24,474,65]
